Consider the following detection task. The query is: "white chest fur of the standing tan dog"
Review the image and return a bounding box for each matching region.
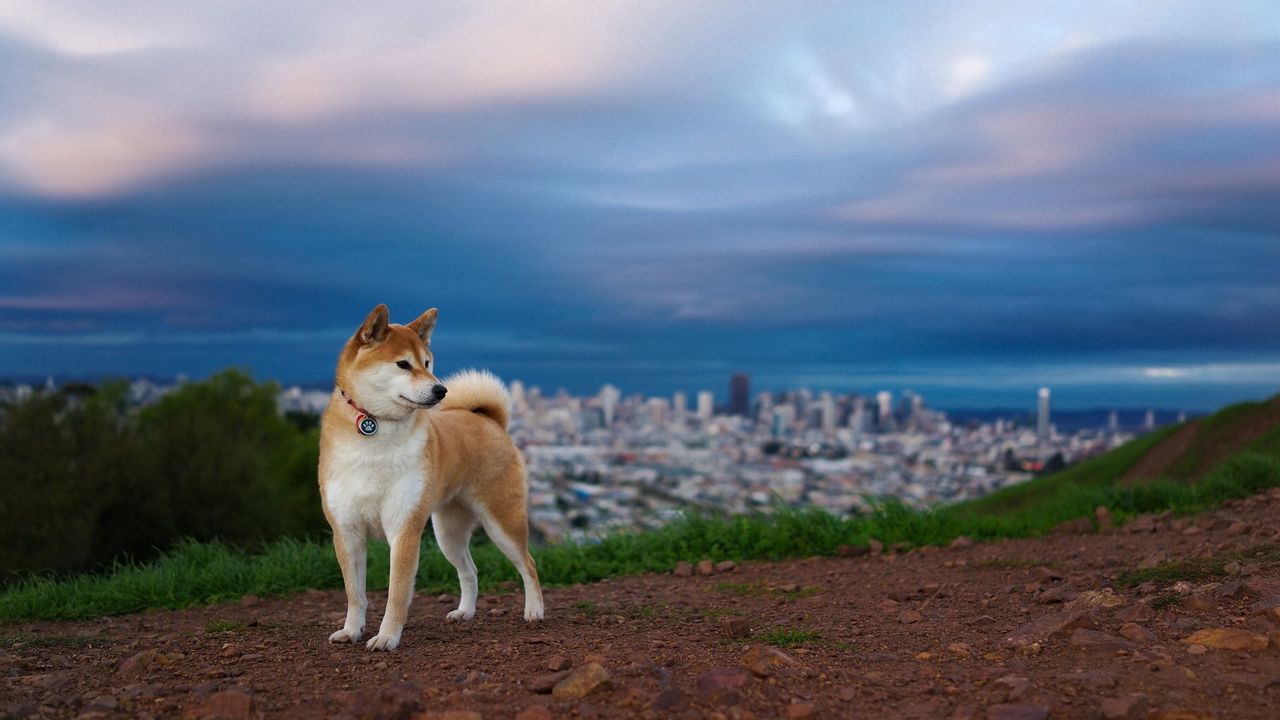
[323,423,428,538]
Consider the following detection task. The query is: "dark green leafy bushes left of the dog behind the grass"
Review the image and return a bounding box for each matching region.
[0,370,325,582]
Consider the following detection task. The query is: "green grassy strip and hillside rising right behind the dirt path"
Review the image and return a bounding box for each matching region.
[0,396,1280,621]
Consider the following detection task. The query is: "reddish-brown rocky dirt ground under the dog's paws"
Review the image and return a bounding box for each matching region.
[0,491,1280,720]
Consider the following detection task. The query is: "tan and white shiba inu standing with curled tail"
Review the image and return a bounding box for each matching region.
[320,305,543,650]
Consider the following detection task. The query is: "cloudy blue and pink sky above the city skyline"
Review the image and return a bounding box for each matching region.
[0,0,1280,409]
